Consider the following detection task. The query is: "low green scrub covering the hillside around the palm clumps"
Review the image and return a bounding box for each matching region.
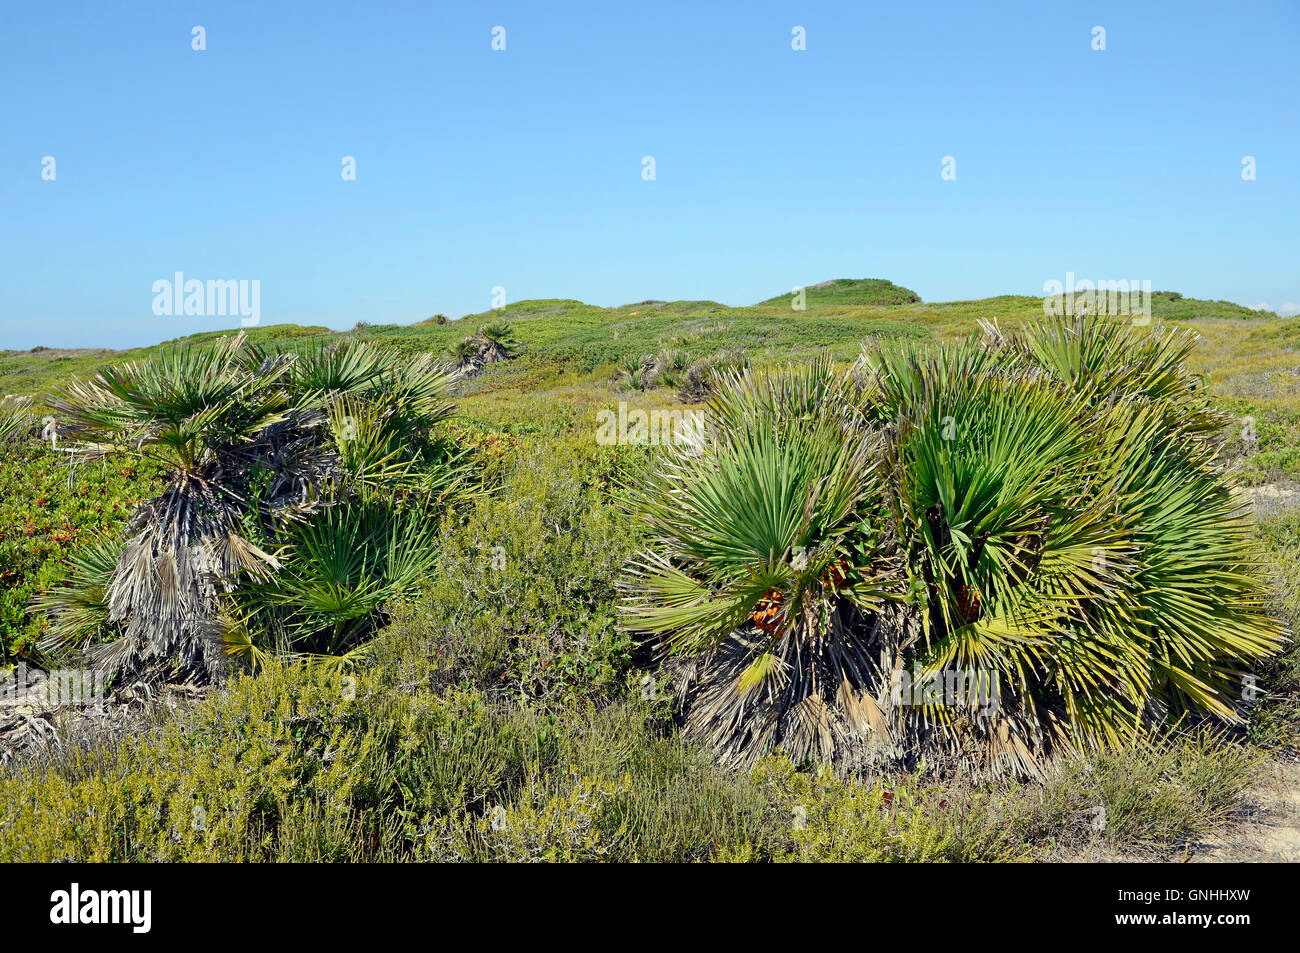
[0,280,1300,861]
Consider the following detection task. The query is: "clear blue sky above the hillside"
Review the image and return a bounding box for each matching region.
[0,0,1300,348]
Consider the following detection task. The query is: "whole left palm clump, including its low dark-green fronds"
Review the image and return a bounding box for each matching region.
[36,335,468,680]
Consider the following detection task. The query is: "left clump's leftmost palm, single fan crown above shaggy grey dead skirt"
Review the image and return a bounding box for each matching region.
[51,335,290,677]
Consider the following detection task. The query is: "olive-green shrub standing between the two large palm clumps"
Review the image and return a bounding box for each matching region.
[389,442,636,699]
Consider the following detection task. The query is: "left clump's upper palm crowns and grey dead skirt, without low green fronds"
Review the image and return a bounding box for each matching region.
[36,335,465,679]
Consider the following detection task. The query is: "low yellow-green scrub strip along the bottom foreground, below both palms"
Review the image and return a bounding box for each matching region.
[0,663,1252,862]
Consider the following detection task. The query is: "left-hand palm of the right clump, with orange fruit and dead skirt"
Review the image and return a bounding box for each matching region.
[624,361,885,762]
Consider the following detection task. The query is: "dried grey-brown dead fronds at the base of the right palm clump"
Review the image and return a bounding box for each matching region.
[668,595,1071,777]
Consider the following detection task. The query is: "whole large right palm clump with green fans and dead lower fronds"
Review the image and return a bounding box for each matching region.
[628,325,1281,772]
